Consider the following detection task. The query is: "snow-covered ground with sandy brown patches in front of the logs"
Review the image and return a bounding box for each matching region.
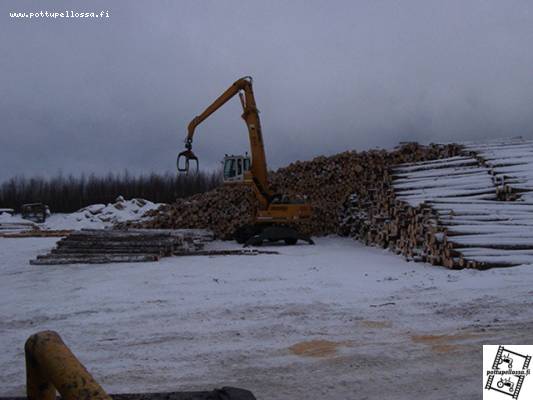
[0,237,533,399]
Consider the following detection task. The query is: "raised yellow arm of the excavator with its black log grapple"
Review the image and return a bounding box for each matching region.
[177,76,269,193]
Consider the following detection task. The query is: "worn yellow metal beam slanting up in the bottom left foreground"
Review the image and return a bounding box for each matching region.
[24,331,111,400]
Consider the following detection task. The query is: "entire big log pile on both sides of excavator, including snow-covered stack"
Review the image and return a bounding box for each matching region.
[122,140,533,269]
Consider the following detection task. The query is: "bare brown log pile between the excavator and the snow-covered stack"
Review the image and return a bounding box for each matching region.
[271,143,461,238]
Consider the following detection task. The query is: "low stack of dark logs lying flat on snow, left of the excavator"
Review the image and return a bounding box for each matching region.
[30,229,213,265]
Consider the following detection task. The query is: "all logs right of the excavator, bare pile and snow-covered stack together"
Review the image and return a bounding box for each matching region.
[274,140,533,269]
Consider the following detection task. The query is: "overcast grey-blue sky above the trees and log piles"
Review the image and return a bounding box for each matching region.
[0,0,533,179]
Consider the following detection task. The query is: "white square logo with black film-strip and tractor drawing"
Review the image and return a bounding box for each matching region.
[483,345,533,400]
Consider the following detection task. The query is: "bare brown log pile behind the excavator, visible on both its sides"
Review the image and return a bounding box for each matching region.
[133,143,461,239]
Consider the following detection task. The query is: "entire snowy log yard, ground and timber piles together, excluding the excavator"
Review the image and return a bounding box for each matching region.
[0,139,533,399]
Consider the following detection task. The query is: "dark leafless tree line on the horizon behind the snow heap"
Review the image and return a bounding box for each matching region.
[0,171,222,212]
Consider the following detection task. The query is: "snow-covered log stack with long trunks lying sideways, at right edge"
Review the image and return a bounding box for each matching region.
[373,140,533,269]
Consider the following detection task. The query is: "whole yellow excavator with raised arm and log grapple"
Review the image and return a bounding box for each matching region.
[177,76,313,245]
